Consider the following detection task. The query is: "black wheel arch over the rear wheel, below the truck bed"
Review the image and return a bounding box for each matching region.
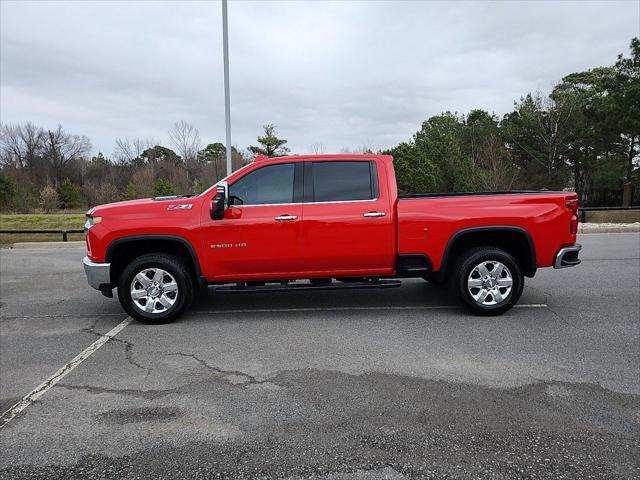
[438,225,538,280]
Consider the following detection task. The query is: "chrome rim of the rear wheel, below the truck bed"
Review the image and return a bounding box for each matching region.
[467,260,513,306]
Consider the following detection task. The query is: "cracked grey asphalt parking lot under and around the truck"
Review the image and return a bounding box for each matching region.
[0,234,640,479]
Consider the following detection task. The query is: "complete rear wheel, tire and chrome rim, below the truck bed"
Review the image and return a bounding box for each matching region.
[452,247,524,315]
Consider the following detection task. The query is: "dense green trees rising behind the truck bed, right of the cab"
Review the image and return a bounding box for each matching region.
[386,38,640,204]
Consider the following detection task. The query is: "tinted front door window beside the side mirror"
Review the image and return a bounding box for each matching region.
[229,163,295,205]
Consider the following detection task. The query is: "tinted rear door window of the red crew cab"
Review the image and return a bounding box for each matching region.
[313,162,373,202]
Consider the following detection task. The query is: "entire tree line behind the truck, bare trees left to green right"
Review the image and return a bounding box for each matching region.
[0,38,640,212]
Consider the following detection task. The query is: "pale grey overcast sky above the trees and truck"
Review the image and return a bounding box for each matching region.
[0,0,640,155]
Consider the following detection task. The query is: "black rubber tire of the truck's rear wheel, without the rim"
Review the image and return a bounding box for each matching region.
[451,247,524,316]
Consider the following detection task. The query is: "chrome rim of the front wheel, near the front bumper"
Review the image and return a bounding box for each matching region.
[130,268,178,314]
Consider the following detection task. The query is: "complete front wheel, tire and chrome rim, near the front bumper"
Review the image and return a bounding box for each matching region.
[118,253,195,324]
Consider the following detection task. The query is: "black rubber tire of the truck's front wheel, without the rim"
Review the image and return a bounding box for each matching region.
[118,253,195,325]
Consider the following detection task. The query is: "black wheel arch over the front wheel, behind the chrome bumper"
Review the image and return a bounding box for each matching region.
[105,235,206,286]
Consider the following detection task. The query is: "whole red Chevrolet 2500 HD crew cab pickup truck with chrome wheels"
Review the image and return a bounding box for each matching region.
[84,154,580,323]
